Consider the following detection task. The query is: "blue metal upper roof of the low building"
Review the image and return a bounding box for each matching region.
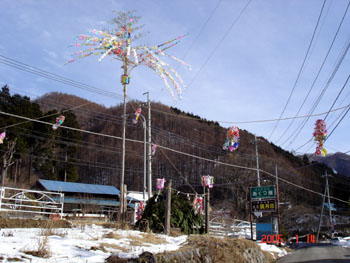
[38,179,120,196]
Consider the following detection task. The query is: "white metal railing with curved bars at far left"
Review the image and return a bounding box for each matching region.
[0,187,64,219]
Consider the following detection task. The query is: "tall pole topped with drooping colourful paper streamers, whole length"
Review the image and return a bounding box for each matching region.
[66,11,191,220]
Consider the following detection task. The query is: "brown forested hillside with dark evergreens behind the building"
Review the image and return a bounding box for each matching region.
[0,87,350,225]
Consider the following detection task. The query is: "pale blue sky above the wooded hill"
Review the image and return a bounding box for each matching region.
[0,0,350,156]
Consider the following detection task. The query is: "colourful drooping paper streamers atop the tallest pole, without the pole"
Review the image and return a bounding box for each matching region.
[66,15,191,100]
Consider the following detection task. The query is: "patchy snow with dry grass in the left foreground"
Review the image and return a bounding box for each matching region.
[0,225,187,263]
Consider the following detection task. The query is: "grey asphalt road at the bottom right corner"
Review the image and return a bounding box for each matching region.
[278,244,350,263]
